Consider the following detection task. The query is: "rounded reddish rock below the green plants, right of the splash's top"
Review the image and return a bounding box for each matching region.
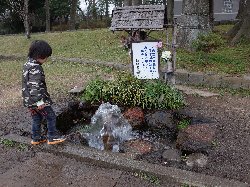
[123,107,144,129]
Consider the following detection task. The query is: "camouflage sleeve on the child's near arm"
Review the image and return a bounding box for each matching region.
[28,66,44,103]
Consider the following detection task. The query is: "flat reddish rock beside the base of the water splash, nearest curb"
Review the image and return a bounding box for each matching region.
[121,139,153,155]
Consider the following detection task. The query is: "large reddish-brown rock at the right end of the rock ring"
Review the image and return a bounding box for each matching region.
[176,124,215,153]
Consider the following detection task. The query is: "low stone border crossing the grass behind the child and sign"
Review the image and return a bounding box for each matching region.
[0,55,250,89]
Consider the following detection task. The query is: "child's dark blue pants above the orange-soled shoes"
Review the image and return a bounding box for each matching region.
[31,106,57,140]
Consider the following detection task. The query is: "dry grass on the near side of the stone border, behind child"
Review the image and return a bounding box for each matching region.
[0,60,120,104]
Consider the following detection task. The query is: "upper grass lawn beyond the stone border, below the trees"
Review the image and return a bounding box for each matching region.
[0,25,250,74]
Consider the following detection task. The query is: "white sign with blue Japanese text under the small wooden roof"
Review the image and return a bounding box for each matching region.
[131,41,159,79]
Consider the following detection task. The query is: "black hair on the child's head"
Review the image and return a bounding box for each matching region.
[28,40,52,60]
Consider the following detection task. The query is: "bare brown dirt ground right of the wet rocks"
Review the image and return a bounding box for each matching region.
[181,93,250,184]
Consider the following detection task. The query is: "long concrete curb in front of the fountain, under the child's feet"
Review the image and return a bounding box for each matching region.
[2,134,249,187]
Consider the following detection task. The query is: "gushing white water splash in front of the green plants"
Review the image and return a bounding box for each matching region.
[82,103,132,152]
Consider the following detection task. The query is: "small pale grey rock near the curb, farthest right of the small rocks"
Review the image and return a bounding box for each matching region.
[186,153,208,167]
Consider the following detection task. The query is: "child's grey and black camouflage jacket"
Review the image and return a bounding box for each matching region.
[22,58,52,108]
